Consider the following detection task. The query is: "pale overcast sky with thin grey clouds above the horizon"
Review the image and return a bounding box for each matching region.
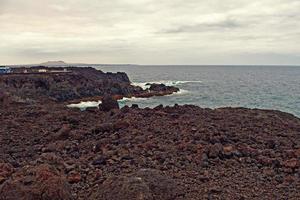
[0,0,300,65]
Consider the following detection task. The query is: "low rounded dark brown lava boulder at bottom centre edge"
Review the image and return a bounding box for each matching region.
[90,169,182,200]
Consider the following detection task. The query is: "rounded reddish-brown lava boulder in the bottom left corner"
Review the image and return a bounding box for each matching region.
[0,164,73,200]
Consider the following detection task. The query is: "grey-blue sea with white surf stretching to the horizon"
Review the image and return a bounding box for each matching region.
[89,66,300,117]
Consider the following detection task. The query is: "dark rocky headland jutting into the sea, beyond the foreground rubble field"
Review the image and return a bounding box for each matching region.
[0,66,179,102]
